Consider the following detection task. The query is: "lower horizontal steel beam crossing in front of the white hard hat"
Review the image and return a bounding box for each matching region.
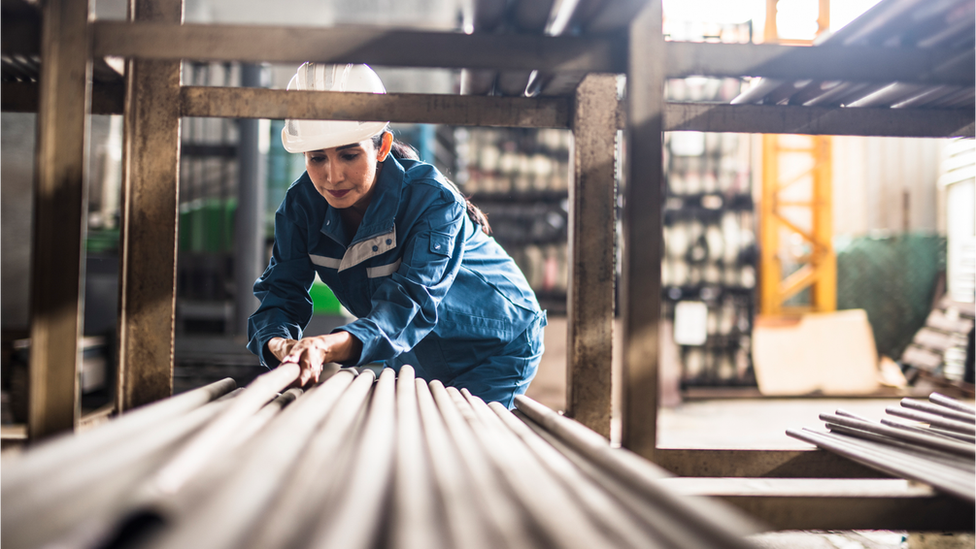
[180,86,570,128]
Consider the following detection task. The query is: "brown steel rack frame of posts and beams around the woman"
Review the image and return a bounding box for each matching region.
[0,0,976,530]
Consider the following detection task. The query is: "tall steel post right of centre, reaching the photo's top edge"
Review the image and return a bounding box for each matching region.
[620,0,664,459]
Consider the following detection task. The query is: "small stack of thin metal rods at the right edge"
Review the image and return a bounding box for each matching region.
[786,393,976,503]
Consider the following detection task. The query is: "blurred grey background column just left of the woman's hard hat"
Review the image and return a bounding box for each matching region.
[233,63,267,335]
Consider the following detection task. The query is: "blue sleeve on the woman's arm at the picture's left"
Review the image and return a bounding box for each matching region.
[247,204,315,367]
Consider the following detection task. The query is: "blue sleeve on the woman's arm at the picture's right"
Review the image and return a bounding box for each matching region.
[338,192,466,365]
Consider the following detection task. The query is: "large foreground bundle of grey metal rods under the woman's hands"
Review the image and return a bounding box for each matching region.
[0,364,756,549]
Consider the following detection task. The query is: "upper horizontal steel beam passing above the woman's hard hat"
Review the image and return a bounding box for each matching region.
[92,21,625,72]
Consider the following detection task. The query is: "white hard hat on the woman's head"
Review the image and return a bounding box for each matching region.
[281,63,389,153]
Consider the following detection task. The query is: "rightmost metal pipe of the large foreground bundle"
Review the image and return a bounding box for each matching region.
[515,395,752,547]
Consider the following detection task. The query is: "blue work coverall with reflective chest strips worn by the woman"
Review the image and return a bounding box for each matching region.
[248,155,546,407]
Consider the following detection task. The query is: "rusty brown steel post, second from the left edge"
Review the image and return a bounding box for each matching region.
[116,0,183,411]
